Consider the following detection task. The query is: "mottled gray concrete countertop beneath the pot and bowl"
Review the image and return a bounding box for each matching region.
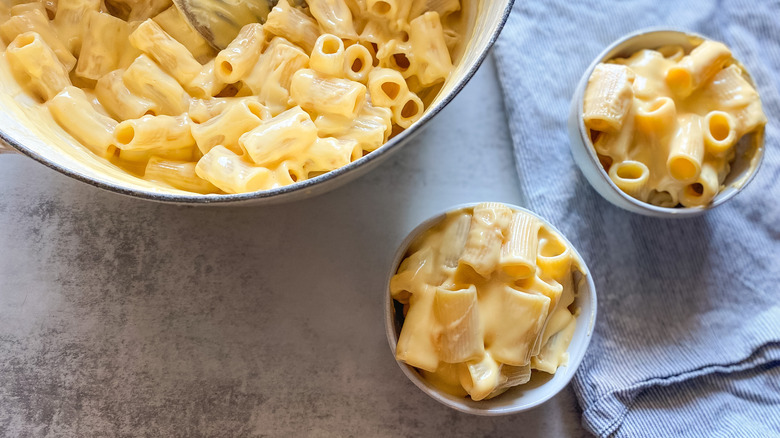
[0,59,584,437]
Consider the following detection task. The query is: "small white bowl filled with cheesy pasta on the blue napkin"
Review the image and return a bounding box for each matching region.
[569,30,766,217]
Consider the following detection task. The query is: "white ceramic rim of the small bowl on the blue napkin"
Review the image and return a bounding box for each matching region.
[574,27,764,218]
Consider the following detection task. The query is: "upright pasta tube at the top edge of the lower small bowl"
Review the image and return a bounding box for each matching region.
[460,203,512,278]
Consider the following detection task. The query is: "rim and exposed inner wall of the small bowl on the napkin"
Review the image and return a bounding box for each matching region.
[575,29,764,217]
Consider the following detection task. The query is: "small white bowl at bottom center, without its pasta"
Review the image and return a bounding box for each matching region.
[382,204,596,416]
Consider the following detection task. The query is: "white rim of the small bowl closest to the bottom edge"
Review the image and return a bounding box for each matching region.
[382,202,598,416]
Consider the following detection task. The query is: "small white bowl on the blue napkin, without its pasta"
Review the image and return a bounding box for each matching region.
[569,29,764,218]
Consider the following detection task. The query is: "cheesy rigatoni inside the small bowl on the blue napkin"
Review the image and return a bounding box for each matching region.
[583,41,766,207]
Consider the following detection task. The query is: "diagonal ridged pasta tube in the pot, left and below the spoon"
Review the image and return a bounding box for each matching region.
[129,19,202,84]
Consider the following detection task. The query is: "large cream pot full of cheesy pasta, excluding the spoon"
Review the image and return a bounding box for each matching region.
[0,0,512,203]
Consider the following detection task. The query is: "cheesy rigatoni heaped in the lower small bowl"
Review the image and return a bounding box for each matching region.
[390,203,583,400]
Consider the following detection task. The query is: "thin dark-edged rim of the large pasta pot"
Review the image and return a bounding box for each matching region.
[0,0,515,204]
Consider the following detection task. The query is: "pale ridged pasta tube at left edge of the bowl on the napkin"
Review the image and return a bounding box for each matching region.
[583,64,636,132]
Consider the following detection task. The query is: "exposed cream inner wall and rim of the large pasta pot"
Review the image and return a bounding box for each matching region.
[0,0,514,205]
